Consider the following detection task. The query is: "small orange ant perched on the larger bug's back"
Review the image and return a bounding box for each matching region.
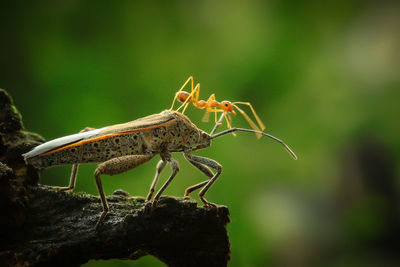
[171,76,265,138]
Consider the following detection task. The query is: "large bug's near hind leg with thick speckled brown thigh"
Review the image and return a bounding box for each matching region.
[94,154,154,229]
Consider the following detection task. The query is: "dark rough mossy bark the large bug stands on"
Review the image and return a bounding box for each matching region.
[0,89,229,266]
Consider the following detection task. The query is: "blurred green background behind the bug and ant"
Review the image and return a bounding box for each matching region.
[0,0,400,266]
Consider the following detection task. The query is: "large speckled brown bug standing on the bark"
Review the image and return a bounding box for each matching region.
[23,99,297,229]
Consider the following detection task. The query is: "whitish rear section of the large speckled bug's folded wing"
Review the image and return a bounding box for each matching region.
[22,127,106,159]
